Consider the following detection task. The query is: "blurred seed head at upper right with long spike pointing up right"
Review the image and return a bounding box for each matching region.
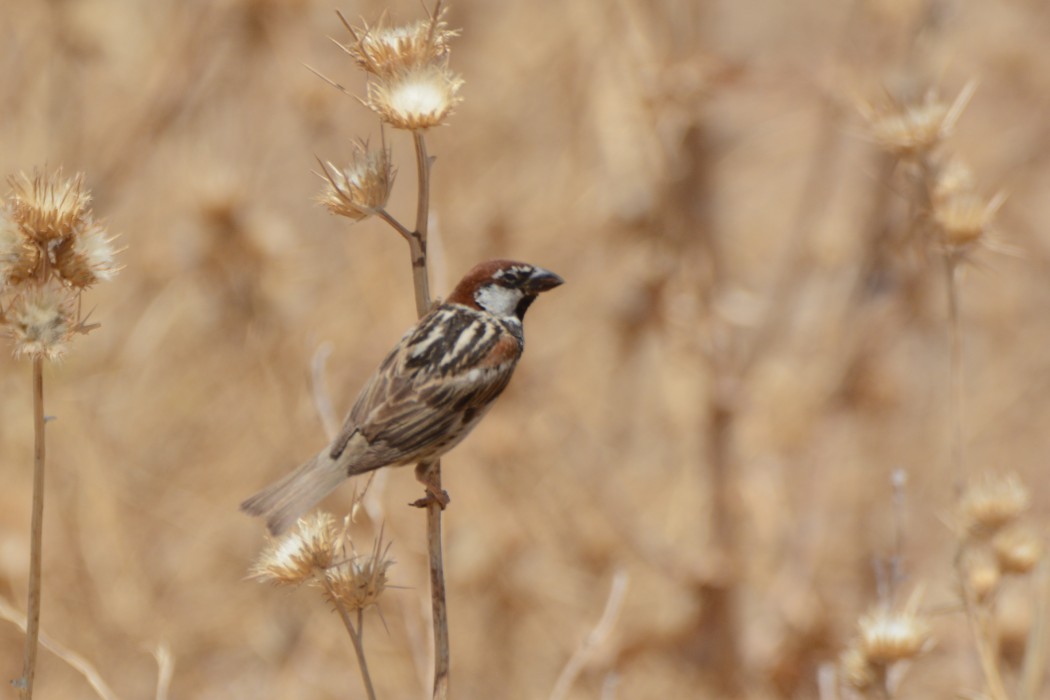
[861,83,977,158]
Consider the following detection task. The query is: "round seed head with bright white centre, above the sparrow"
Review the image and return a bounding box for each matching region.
[366,64,463,131]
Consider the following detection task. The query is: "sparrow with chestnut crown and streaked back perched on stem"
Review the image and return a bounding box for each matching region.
[240,260,564,535]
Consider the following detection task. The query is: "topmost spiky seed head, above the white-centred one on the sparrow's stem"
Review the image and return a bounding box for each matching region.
[339,9,459,77]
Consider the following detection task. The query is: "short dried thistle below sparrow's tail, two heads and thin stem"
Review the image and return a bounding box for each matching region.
[251,511,394,700]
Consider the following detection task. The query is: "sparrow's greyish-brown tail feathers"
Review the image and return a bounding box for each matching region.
[240,450,347,535]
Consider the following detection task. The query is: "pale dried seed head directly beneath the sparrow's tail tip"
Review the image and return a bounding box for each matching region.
[251,512,337,586]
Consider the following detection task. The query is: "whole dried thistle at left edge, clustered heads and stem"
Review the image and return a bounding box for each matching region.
[0,170,119,699]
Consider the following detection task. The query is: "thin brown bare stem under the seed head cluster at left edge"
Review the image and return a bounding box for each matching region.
[20,355,44,700]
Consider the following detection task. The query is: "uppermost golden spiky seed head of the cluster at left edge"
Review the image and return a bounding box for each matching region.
[9,170,91,245]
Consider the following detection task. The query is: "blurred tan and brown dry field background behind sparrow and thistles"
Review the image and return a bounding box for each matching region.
[0,0,1050,699]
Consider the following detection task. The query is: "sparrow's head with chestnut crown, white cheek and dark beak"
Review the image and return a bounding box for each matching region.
[446,260,565,321]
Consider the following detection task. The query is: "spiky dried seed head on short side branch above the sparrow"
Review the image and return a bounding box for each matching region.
[318,142,397,221]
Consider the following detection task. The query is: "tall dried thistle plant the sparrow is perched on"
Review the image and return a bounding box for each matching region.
[306,0,463,699]
